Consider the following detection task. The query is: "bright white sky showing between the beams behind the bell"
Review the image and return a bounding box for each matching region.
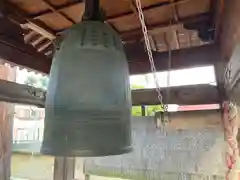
[17,66,216,88]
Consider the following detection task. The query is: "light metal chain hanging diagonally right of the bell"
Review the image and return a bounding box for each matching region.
[135,0,167,111]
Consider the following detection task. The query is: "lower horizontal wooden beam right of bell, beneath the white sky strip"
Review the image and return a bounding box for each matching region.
[132,84,219,106]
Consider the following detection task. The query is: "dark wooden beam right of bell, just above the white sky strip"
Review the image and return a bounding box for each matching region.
[125,43,220,74]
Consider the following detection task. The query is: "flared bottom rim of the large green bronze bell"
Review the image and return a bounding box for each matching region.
[40,146,133,157]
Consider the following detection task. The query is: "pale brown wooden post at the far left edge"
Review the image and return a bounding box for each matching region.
[0,64,15,180]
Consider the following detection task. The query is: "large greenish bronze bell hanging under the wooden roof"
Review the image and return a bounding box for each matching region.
[41,21,131,157]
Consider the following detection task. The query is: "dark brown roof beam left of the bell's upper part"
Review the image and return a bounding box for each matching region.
[0,12,51,73]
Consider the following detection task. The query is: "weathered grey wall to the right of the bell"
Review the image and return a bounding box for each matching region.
[82,113,225,180]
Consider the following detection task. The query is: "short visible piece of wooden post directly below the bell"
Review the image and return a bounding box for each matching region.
[53,157,75,180]
